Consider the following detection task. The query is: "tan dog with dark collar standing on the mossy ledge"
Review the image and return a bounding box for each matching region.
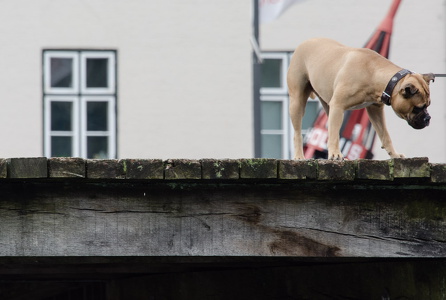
[287,39,435,160]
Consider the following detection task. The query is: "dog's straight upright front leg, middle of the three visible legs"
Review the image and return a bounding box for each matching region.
[327,106,344,160]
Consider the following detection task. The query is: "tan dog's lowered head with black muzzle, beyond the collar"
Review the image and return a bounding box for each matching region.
[391,73,435,129]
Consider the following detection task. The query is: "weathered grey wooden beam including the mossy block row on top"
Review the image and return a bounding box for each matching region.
[0,158,446,258]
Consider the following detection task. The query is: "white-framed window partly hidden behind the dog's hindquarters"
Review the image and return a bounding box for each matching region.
[259,52,319,159]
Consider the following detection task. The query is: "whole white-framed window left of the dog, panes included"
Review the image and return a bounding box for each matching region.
[43,50,116,158]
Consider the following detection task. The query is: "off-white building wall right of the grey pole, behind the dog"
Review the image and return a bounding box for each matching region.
[260,0,446,163]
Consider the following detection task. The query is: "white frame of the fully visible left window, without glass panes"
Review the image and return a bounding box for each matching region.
[42,49,118,159]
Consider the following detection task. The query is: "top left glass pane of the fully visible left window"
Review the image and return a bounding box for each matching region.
[50,57,73,88]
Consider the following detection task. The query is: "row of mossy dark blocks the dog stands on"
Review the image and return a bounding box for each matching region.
[0,157,446,183]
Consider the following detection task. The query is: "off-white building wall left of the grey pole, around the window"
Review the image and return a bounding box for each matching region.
[0,0,253,158]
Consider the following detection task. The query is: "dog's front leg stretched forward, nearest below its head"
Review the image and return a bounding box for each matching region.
[367,104,404,158]
